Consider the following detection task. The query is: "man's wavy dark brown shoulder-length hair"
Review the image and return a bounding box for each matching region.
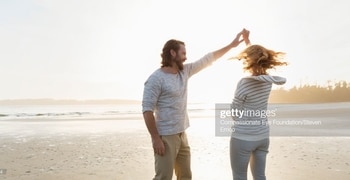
[161,39,185,67]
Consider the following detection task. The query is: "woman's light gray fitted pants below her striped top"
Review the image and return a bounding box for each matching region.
[230,137,269,180]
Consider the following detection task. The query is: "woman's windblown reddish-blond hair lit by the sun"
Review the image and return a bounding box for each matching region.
[236,45,287,76]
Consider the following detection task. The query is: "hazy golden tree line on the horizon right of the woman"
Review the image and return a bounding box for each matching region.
[269,81,350,103]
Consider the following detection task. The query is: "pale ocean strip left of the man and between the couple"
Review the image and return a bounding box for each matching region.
[0,103,215,121]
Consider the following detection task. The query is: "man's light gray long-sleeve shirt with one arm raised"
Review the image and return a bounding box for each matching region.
[142,53,215,135]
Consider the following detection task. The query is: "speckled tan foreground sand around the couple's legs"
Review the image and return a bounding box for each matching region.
[0,132,350,180]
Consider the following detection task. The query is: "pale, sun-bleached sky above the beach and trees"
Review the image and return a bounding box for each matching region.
[0,0,350,102]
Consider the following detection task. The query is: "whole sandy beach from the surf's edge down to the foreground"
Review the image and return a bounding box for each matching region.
[0,114,350,180]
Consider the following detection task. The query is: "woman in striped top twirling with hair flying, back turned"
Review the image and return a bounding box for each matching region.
[230,37,287,180]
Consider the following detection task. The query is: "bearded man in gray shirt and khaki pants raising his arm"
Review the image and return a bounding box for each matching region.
[142,29,249,180]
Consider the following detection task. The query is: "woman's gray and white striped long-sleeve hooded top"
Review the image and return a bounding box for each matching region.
[231,75,286,141]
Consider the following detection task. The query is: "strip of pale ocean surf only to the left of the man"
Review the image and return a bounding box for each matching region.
[0,104,141,120]
